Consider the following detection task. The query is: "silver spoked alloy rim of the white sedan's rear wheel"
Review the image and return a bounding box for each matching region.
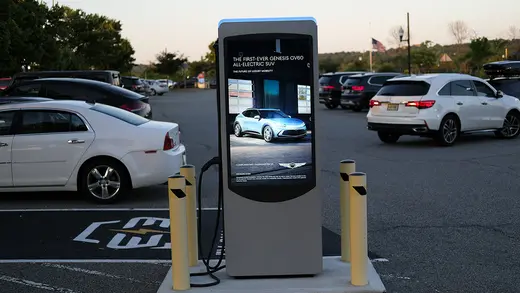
[87,165,121,200]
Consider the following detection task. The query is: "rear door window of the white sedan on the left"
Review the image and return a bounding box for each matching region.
[16,110,88,134]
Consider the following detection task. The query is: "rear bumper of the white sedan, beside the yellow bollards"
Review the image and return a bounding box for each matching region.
[121,144,186,188]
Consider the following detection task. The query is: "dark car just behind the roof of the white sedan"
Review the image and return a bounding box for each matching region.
[0,78,152,119]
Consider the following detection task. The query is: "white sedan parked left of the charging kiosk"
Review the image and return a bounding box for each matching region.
[0,101,186,203]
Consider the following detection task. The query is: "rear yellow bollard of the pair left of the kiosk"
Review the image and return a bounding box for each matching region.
[181,165,199,267]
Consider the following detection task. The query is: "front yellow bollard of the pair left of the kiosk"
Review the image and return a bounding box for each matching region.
[168,175,190,291]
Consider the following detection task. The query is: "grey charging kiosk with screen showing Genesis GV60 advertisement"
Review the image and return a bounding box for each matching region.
[218,18,323,277]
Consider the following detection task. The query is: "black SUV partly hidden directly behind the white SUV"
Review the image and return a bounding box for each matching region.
[341,72,404,112]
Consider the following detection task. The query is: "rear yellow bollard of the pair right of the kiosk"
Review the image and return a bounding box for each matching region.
[339,160,356,262]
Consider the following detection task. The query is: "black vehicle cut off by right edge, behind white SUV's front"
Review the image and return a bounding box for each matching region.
[483,61,520,99]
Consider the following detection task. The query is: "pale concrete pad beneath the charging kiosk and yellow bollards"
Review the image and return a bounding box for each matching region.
[157,257,386,293]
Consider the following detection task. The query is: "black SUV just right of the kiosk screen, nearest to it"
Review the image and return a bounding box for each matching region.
[319,71,363,109]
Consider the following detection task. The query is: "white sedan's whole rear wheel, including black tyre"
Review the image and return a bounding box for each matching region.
[79,159,131,203]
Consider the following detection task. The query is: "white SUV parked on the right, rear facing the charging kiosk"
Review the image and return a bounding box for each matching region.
[367,73,520,146]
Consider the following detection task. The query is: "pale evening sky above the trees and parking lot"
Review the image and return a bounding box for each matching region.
[46,0,520,64]
